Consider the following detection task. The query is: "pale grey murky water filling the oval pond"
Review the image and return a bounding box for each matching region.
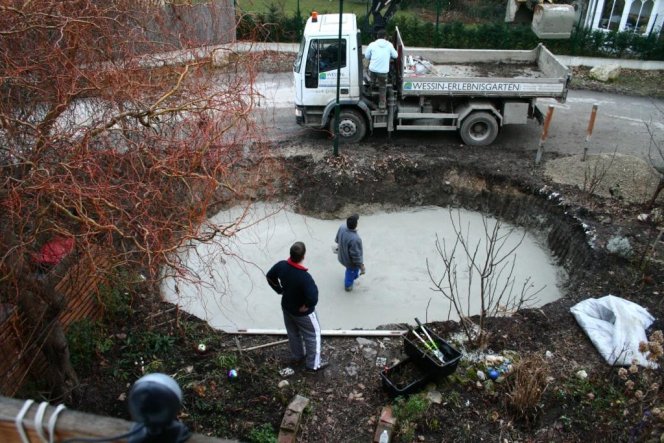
[162,203,566,333]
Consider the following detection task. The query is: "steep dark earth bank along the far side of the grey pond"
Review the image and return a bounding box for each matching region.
[293,155,598,278]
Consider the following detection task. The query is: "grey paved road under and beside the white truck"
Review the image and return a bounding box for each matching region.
[257,73,664,164]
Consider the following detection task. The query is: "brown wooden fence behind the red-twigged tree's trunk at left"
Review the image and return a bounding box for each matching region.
[0,253,110,398]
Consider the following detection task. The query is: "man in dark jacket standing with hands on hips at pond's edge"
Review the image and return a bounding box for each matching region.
[266,242,327,372]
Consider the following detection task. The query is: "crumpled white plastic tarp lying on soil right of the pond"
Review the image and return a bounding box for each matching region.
[570,295,657,367]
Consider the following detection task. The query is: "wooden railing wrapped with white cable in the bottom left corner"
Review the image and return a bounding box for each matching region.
[0,397,238,443]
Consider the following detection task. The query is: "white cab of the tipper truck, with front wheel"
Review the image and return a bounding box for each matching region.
[293,12,370,141]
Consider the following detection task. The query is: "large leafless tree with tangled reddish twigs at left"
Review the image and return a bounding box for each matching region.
[0,0,271,397]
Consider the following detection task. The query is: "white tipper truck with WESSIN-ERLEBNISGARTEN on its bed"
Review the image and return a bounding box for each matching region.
[293,13,571,146]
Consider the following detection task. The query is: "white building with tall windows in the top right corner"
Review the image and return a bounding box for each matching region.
[583,0,664,35]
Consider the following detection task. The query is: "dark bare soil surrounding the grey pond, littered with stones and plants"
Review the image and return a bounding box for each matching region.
[36,51,664,442]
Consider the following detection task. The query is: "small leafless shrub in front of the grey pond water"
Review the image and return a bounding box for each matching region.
[427,210,544,346]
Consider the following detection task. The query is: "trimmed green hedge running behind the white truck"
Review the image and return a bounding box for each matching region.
[237,11,664,60]
